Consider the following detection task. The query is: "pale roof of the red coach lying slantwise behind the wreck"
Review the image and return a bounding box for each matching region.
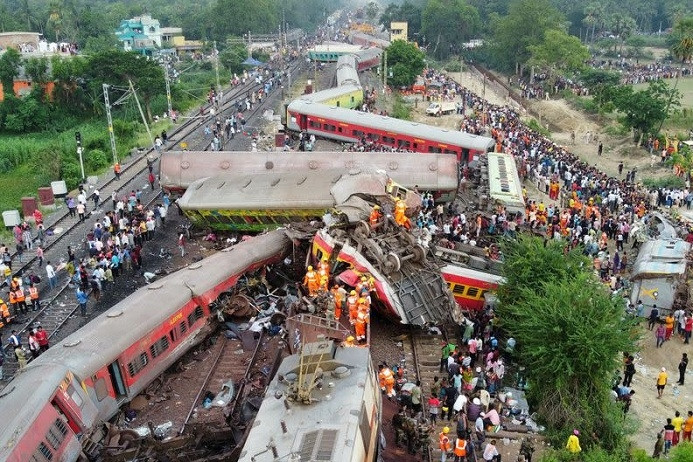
[288,100,495,152]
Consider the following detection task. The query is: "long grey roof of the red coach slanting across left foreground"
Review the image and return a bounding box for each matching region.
[28,231,290,380]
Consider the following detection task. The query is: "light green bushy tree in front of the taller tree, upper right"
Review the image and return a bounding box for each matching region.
[529,29,590,73]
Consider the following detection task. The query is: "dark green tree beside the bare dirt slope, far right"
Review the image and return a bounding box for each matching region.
[610,80,681,144]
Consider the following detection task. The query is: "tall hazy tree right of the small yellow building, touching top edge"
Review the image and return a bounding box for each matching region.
[421,0,481,59]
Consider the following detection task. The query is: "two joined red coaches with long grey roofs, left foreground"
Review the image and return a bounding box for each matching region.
[0,231,291,462]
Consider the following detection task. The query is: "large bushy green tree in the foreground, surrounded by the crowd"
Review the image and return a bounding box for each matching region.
[497,236,636,449]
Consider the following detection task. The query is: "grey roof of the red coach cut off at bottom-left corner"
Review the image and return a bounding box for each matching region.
[0,360,73,460]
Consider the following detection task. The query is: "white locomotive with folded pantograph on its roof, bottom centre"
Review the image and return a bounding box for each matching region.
[238,341,382,462]
